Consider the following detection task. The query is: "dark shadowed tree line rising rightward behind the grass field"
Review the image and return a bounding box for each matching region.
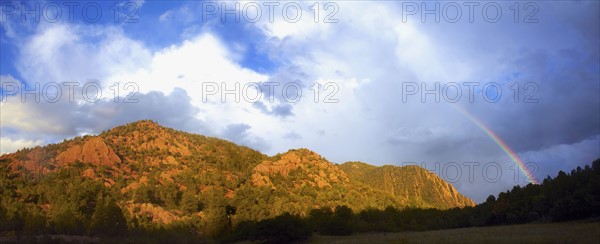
[224,159,600,243]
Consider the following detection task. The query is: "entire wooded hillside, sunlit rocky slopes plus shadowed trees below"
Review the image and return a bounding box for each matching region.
[0,121,600,242]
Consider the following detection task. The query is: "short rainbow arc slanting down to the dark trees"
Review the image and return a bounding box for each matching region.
[452,104,539,184]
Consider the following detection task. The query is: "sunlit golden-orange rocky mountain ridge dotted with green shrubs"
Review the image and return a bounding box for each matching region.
[0,120,474,233]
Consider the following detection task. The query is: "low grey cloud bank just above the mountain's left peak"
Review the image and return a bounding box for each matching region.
[2,88,214,142]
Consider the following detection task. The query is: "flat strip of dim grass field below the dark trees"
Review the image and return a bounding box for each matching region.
[310,222,600,244]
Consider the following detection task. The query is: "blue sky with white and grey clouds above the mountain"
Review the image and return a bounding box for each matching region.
[0,1,600,202]
